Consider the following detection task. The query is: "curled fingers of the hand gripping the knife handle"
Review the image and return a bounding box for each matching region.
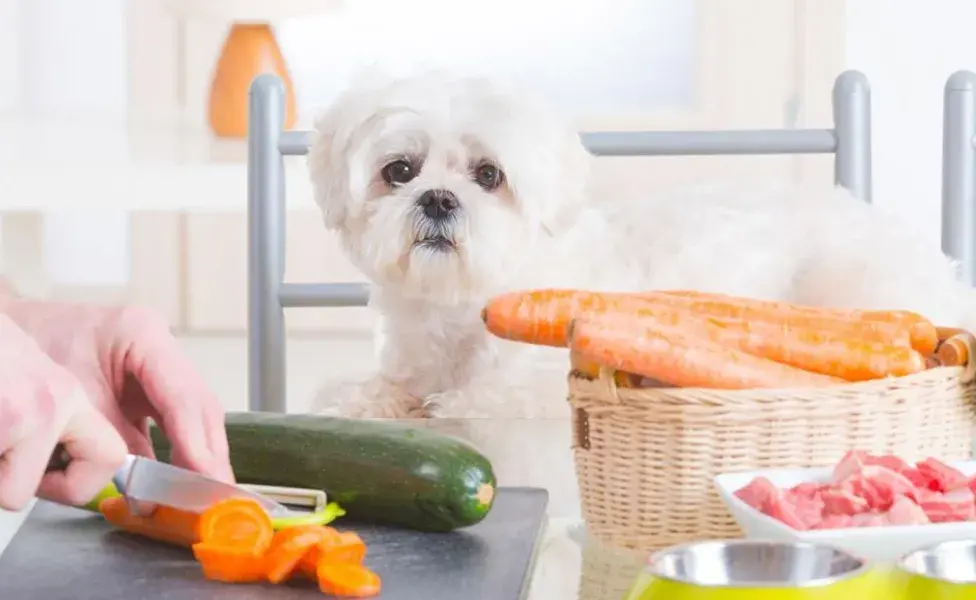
[37,406,127,505]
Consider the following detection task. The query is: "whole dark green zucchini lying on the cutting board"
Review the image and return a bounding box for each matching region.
[152,412,495,532]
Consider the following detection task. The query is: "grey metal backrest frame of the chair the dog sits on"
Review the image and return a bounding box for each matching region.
[247,71,871,412]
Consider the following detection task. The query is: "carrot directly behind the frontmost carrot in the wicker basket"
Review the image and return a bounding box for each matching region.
[660,317,926,381]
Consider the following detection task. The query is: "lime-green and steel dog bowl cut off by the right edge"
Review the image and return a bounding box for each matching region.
[893,540,976,600]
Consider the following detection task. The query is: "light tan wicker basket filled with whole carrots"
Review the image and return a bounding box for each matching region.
[569,334,976,551]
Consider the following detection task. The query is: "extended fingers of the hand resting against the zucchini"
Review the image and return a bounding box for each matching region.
[120,311,234,482]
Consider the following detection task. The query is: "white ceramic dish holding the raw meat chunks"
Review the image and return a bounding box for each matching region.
[715,461,976,563]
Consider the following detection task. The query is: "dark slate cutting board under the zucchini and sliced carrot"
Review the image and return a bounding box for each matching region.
[0,488,549,600]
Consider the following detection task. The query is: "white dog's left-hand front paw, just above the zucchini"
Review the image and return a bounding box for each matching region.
[313,378,427,419]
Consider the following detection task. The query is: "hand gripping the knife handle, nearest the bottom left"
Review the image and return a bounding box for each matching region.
[0,315,126,510]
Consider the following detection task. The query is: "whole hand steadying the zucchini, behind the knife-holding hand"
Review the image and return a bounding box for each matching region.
[0,298,234,482]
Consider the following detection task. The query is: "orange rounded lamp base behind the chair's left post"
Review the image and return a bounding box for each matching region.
[210,24,296,138]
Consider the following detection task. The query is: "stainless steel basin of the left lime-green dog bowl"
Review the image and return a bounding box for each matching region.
[648,540,870,589]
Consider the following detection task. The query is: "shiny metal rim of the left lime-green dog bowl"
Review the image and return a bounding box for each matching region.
[647,539,873,589]
